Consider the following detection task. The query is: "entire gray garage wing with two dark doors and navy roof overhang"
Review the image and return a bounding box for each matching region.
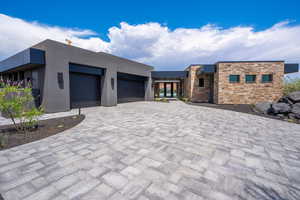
[0,40,153,112]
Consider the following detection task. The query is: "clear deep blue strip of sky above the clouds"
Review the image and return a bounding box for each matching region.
[0,0,300,39]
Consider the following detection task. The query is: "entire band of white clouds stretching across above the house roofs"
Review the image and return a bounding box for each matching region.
[0,14,300,77]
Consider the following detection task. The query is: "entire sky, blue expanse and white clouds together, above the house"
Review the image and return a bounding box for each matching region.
[0,0,300,77]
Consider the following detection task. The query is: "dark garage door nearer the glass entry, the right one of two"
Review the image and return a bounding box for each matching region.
[117,73,145,103]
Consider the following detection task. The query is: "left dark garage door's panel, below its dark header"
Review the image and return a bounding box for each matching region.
[70,72,101,108]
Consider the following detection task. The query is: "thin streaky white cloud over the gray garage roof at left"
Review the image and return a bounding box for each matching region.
[0,14,108,59]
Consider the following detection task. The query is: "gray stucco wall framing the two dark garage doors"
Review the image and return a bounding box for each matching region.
[33,40,153,112]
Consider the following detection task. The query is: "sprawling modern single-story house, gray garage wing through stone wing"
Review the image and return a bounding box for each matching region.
[0,40,298,112]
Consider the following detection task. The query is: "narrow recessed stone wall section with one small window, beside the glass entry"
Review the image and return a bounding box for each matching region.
[185,66,212,102]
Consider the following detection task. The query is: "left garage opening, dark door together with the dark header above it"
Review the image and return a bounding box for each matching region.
[70,64,103,108]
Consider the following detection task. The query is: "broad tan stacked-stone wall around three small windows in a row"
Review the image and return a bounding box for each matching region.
[214,62,284,104]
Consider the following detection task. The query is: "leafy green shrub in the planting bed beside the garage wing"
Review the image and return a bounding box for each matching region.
[0,84,43,132]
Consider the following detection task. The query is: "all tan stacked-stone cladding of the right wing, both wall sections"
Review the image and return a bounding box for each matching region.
[185,61,284,104]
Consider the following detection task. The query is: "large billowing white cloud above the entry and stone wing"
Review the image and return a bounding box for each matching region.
[109,22,300,69]
